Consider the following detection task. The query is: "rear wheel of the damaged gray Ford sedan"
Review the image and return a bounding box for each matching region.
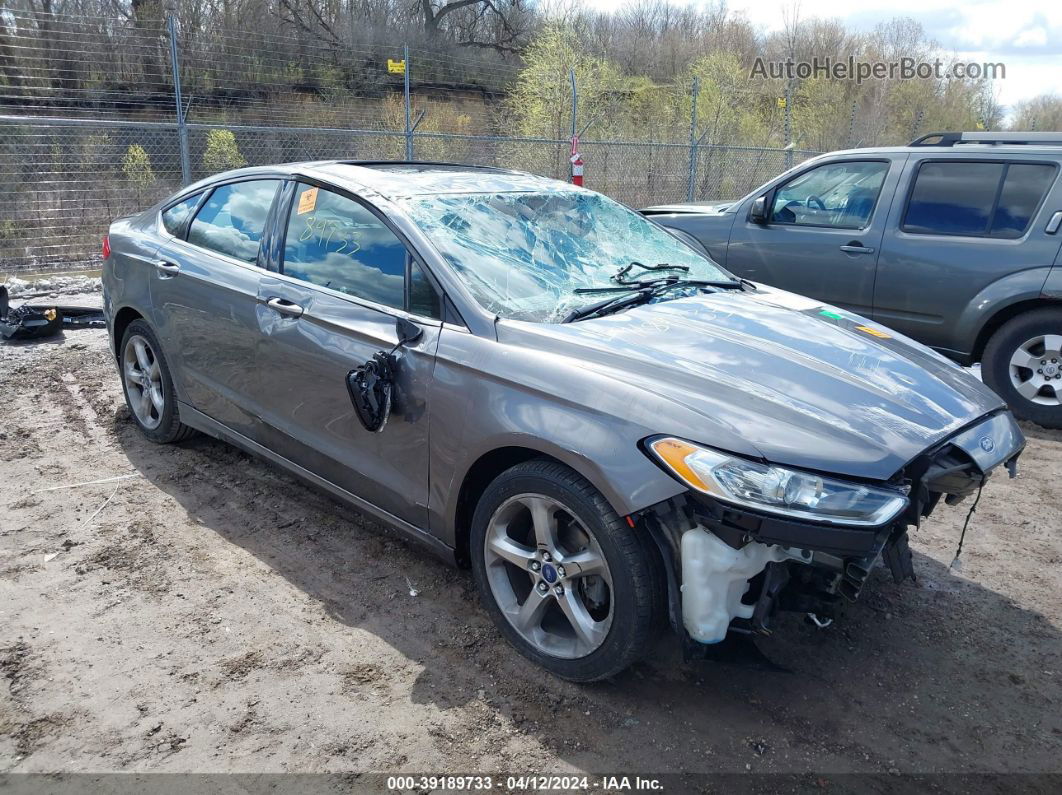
[119,321,194,445]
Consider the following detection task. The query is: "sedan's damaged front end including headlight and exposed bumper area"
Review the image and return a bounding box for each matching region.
[641,412,1025,647]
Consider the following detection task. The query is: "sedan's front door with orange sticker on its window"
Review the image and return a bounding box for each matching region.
[257,183,442,529]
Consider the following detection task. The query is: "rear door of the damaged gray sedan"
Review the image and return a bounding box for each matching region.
[151,178,281,438]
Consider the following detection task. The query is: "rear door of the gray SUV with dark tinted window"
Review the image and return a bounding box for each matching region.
[874,158,1062,353]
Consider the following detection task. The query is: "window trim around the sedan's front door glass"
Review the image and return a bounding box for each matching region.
[270,174,452,325]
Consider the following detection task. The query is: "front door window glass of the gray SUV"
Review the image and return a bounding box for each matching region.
[770,161,889,229]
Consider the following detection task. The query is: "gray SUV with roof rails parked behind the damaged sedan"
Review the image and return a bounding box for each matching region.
[643,133,1062,428]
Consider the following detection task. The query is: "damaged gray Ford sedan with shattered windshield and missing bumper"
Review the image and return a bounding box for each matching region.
[103,161,1024,680]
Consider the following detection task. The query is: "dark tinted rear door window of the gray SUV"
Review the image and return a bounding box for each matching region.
[902,160,1056,239]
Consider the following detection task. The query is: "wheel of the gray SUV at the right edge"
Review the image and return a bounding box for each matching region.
[981,309,1062,428]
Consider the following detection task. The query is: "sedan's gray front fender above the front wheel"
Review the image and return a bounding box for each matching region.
[428,327,685,547]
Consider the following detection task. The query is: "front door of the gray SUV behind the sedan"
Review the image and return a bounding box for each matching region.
[726,158,903,315]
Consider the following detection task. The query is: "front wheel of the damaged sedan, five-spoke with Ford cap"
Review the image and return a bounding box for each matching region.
[470,460,664,681]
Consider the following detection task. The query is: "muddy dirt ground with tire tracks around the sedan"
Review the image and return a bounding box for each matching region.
[0,307,1062,774]
